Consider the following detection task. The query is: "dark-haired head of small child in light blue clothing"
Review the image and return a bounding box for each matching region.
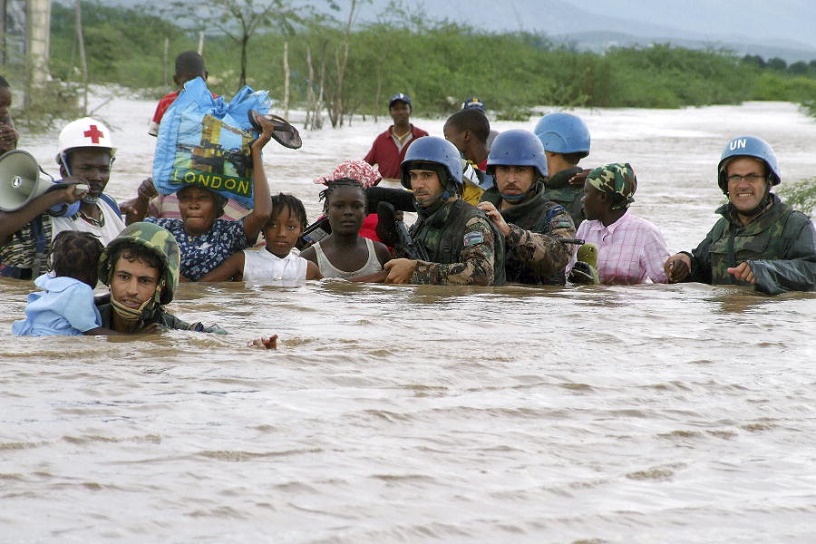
[51,231,105,289]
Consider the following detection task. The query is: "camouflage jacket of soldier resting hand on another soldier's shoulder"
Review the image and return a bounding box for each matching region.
[482,182,575,285]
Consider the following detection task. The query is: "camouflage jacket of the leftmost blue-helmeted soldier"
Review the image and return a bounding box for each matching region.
[410,199,504,285]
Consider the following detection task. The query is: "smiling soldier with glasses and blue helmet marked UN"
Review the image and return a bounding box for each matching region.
[664,136,816,295]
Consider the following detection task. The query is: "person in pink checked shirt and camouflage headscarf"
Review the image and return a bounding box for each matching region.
[567,163,669,285]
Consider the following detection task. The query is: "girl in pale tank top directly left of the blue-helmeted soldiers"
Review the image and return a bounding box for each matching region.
[301,178,391,281]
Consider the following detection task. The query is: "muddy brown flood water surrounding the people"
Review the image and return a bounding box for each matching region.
[0,92,816,544]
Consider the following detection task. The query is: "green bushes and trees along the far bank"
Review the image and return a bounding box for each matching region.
[30,0,816,123]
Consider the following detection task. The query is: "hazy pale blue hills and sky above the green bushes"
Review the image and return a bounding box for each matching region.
[86,0,816,63]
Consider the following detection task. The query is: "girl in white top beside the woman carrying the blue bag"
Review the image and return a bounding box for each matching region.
[199,193,321,287]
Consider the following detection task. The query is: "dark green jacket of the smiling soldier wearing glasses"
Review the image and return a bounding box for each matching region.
[686,194,816,295]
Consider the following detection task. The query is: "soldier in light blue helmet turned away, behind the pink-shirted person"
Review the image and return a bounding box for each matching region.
[533,112,590,228]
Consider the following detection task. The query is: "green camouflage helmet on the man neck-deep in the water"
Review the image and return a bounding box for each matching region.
[99,222,181,304]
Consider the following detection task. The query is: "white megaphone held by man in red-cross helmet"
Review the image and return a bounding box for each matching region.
[0,149,88,212]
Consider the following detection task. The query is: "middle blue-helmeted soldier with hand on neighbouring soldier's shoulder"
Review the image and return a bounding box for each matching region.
[479,130,575,285]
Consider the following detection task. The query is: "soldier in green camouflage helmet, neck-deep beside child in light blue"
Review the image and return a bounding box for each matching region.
[99,222,225,334]
